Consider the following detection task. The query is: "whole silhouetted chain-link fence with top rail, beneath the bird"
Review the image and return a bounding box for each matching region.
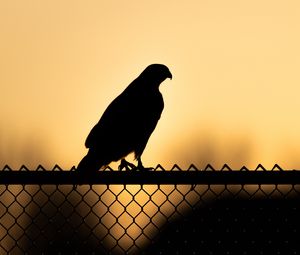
[0,165,300,254]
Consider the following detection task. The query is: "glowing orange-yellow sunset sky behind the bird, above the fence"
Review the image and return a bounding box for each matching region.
[0,0,300,169]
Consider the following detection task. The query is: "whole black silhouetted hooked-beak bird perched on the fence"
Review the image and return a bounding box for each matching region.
[77,64,172,174]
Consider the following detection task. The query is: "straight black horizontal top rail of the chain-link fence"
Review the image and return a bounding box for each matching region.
[0,167,300,185]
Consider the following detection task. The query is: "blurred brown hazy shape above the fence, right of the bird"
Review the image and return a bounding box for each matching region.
[171,130,255,169]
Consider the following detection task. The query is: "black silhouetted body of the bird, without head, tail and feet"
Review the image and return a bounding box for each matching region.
[85,78,163,164]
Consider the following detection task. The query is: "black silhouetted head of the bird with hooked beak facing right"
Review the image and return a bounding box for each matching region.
[140,64,172,85]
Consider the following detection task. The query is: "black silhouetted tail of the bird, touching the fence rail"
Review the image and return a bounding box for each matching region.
[76,151,104,175]
